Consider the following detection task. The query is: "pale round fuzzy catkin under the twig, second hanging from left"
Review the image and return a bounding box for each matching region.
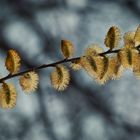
[19,71,39,93]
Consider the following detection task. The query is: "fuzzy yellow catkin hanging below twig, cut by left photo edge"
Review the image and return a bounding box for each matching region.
[0,83,17,108]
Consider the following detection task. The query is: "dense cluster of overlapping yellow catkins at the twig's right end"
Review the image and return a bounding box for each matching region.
[80,26,140,84]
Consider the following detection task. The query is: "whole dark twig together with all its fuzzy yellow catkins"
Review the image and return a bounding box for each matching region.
[0,26,140,108]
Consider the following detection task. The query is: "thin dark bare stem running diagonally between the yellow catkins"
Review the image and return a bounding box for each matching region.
[0,45,140,83]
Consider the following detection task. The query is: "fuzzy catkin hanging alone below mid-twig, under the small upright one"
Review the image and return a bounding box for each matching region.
[50,65,70,91]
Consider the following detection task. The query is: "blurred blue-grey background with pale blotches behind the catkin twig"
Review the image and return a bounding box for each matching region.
[0,0,140,140]
